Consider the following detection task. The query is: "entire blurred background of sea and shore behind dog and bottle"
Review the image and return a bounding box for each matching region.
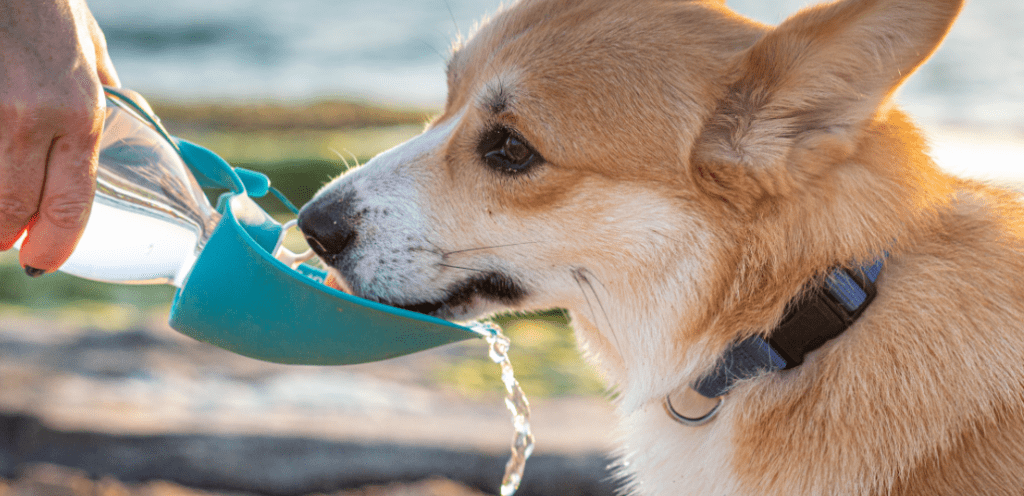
[0,0,1024,496]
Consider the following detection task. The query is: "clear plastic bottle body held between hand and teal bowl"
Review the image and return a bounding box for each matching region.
[14,90,220,287]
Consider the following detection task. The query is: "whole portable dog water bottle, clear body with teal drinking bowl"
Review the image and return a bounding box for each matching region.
[28,88,480,365]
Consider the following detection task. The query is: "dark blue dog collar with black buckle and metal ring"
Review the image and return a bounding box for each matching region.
[666,257,885,425]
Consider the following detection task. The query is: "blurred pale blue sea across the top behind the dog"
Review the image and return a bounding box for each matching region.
[89,0,1024,130]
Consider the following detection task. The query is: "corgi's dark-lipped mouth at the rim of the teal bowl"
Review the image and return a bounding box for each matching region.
[367,272,526,320]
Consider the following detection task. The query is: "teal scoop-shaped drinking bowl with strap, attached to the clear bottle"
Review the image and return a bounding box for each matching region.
[108,89,481,365]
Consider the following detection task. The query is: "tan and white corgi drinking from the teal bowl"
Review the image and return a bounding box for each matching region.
[300,0,1024,496]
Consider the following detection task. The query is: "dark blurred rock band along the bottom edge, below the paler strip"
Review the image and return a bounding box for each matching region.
[0,414,615,496]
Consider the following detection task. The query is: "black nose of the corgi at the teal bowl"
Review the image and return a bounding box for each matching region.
[299,192,358,260]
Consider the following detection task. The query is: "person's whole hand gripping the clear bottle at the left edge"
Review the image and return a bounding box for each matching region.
[0,0,120,277]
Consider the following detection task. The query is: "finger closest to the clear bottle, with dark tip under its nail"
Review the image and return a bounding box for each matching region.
[19,121,101,273]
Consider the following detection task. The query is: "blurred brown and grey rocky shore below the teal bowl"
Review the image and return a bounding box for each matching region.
[0,319,615,496]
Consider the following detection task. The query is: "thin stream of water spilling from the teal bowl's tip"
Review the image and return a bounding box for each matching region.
[470,322,534,496]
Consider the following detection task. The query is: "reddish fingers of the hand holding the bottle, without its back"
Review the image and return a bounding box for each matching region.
[0,81,105,275]
